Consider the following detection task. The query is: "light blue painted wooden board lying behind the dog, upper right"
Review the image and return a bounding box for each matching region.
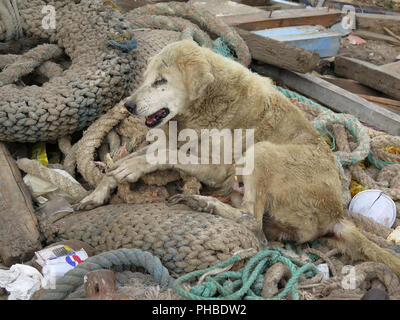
[252,26,341,58]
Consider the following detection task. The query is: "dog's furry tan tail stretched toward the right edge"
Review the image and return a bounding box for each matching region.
[329,218,400,277]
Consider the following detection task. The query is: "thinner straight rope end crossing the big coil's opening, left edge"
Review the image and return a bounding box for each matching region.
[0,44,62,86]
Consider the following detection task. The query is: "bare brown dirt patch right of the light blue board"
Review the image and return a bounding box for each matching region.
[338,37,400,66]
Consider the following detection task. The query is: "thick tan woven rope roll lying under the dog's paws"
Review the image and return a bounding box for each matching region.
[39,202,260,274]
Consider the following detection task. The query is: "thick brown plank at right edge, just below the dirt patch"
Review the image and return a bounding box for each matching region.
[335,56,400,99]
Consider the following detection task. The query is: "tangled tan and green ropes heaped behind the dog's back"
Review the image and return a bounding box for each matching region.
[277,87,400,222]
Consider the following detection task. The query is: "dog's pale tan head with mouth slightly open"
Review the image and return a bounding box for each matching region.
[125,40,214,128]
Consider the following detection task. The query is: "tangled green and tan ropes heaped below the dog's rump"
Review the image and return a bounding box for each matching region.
[174,245,400,300]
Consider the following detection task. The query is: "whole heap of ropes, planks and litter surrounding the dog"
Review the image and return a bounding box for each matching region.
[0,0,400,300]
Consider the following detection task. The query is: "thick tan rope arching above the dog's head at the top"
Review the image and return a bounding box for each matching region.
[129,2,251,66]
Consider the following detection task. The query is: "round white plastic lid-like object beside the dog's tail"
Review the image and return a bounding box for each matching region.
[349,189,396,228]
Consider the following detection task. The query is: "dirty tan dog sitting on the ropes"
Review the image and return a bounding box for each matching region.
[78,40,400,276]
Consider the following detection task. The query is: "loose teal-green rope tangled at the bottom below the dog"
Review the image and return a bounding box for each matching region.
[173,247,319,300]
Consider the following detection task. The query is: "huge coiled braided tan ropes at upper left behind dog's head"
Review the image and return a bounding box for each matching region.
[0,0,251,142]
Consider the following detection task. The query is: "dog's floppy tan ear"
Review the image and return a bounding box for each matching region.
[180,54,214,101]
